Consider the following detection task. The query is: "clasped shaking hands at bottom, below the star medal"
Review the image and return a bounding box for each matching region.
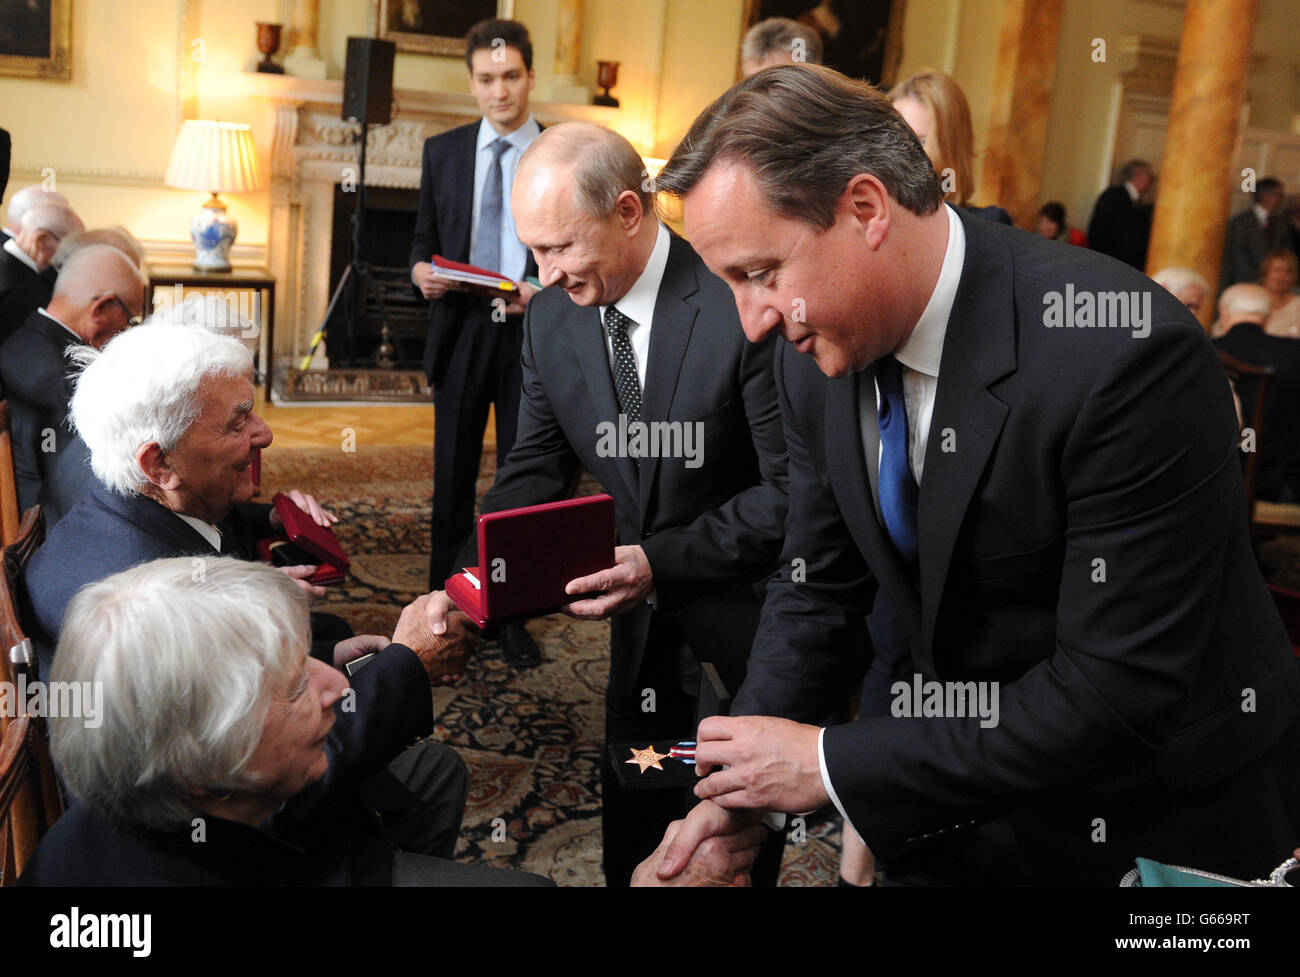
[632,800,767,886]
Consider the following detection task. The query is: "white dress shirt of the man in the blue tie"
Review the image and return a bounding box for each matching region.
[816,204,966,841]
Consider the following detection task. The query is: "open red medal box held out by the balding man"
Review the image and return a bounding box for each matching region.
[447,495,615,628]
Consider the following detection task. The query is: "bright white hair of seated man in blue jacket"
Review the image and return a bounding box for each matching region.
[69,325,252,495]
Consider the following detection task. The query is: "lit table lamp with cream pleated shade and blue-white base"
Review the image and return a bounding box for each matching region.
[163,120,263,272]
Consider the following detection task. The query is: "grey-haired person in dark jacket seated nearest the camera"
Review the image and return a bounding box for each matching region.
[20,556,547,886]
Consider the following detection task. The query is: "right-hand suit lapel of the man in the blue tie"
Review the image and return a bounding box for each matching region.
[917,207,1015,664]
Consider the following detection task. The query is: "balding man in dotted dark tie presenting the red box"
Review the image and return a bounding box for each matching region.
[434,123,787,886]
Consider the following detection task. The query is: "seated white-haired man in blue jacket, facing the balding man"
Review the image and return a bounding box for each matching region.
[20,325,468,856]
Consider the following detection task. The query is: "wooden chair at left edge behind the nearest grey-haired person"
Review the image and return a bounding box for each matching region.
[0,505,64,886]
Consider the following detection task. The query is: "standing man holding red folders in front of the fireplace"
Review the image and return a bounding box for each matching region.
[411,21,540,666]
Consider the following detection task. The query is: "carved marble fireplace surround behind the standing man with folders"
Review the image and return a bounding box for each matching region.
[257,75,619,370]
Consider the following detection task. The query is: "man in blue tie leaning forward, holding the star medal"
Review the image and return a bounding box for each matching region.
[659,66,1300,885]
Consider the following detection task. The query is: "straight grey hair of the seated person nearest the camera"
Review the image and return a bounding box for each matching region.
[49,556,311,829]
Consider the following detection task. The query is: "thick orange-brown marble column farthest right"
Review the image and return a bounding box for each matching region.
[1147,0,1258,325]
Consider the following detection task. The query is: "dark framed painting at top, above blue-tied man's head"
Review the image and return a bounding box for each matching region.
[736,0,907,90]
